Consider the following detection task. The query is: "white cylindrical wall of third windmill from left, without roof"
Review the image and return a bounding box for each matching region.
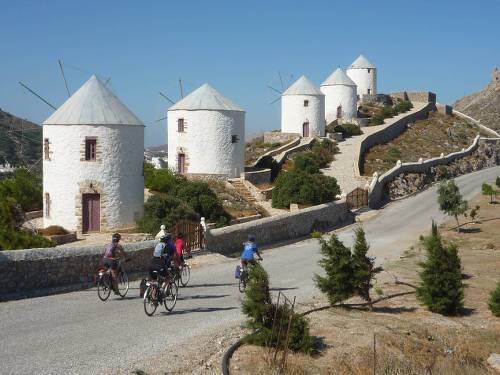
[281,95,325,137]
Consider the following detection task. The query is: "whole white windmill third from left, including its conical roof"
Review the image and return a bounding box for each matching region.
[281,76,325,137]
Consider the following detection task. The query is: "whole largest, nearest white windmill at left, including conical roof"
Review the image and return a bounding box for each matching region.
[43,75,144,233]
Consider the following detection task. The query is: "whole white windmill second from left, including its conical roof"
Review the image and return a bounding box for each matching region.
[167,84,245,178]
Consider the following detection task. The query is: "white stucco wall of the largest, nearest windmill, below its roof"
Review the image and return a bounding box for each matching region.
[43,125,144,230]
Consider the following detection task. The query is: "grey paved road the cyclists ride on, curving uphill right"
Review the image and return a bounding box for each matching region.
[0,167,500,374]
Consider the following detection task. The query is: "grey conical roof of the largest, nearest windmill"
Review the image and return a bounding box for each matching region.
[43,75,144,126]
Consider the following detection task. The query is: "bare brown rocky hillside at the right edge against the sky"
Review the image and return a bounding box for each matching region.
[453,68,500,131]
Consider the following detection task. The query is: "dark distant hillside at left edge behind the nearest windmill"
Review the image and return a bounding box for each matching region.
[0,110,42,170]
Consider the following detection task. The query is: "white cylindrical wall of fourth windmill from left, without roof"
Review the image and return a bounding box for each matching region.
[320,85,358,124]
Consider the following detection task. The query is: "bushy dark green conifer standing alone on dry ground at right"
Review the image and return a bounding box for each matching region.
[417,222,464,315]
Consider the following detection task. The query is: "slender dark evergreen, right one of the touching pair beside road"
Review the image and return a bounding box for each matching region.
[352,227,382,310]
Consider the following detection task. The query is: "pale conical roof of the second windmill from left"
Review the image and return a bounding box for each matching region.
[168,83,245,112]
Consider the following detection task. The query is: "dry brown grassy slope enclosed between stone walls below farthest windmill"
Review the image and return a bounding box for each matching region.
[364,112,478,176]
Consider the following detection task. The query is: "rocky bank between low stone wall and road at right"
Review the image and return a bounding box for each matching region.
[385,143,500,200]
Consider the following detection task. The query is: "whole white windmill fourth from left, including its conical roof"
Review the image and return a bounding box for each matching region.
[320,68,358,124]
